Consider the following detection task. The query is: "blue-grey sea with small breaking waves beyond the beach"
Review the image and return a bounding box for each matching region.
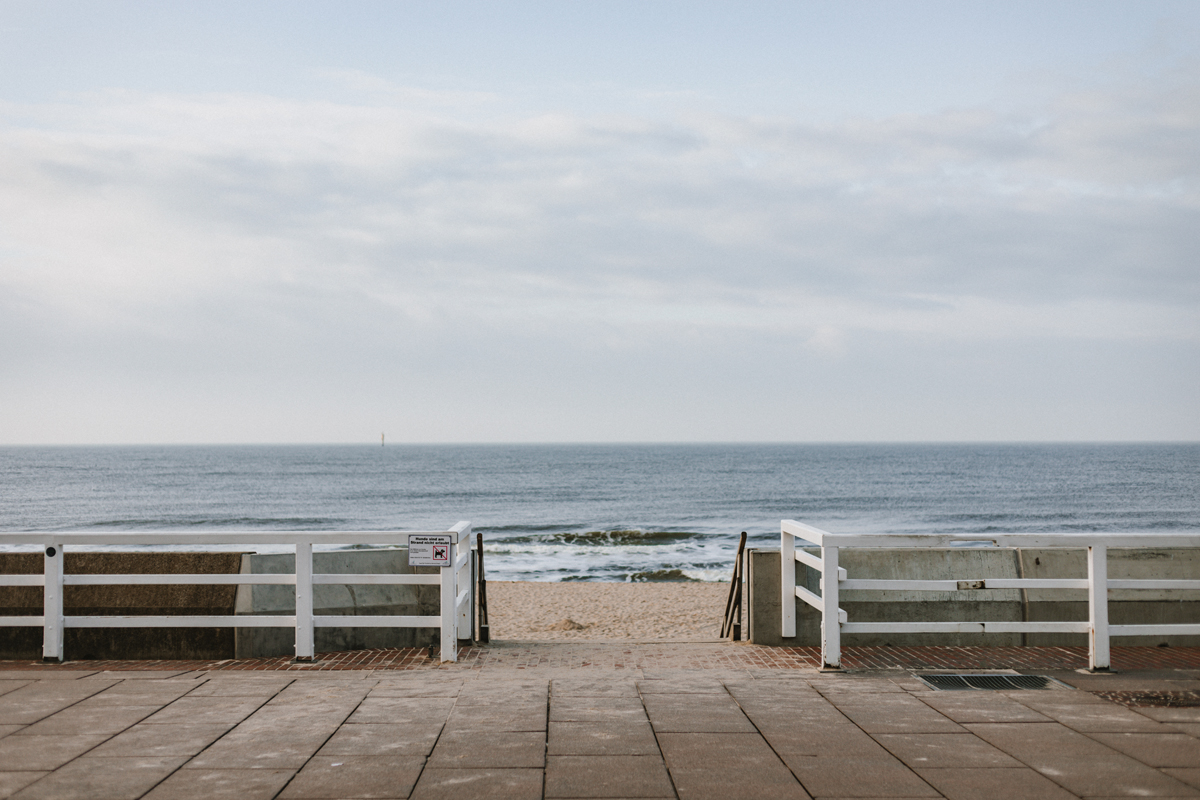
[0,444,1200,582]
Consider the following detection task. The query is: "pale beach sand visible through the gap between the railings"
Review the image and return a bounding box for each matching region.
[487,581,730,642]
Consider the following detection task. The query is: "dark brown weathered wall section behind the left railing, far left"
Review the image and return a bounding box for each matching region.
[0,552,241,658]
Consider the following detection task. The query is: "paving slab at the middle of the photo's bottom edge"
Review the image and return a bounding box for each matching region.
[546,756,674,800]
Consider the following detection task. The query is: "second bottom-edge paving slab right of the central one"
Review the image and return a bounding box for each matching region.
[780,753,938,798]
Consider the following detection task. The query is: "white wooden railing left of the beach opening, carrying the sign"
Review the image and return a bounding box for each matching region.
[0,522,474,661]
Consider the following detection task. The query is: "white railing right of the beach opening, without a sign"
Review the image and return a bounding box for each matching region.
[780,519,1200,670]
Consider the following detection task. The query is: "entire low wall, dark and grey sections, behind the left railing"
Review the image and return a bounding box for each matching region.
[0,548,440,661]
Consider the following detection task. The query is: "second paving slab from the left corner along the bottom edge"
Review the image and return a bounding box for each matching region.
[9,757,186,800]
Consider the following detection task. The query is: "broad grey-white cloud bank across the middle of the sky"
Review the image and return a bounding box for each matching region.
[0,67,1200,443]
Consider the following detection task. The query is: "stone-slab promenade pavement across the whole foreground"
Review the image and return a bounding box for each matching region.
[0,643,1200,800]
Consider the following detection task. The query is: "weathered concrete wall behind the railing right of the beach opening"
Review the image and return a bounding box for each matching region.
[746,548,1200,646]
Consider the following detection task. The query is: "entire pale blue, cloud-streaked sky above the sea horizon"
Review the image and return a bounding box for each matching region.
[0,0,1200,444]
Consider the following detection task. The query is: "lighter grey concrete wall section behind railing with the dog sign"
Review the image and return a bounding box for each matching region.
[234,548,442,658]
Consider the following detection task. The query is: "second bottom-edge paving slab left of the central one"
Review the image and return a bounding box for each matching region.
[280,756,425,800]
